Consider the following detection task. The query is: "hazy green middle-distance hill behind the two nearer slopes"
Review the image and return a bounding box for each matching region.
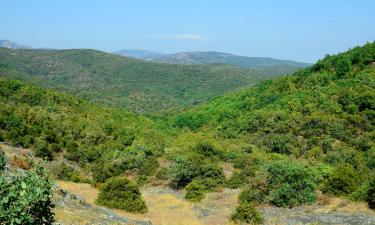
[0,48,290,113]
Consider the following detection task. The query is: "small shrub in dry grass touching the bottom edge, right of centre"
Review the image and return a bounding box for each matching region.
[231,203,263,224]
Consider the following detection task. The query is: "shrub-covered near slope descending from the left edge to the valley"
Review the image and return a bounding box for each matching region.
[0,79,166,183]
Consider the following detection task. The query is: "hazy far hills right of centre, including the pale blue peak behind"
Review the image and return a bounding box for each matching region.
[114,49,309,68]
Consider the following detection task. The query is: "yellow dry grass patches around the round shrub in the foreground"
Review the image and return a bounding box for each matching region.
[57,181,239,225]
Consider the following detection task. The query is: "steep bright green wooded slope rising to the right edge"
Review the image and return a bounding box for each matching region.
[174,43,375,161]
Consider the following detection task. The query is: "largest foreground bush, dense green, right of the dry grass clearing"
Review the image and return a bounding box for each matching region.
[245,160,316,207]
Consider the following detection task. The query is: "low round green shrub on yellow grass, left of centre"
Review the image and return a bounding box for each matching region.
[96,177,147,213]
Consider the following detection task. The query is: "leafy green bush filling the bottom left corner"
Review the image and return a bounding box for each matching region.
[0,165,54,225]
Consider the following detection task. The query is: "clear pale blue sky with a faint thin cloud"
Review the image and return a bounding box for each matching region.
[0,0,375,63]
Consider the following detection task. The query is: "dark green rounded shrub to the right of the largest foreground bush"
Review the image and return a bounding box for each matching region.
[324,163,359,195]
